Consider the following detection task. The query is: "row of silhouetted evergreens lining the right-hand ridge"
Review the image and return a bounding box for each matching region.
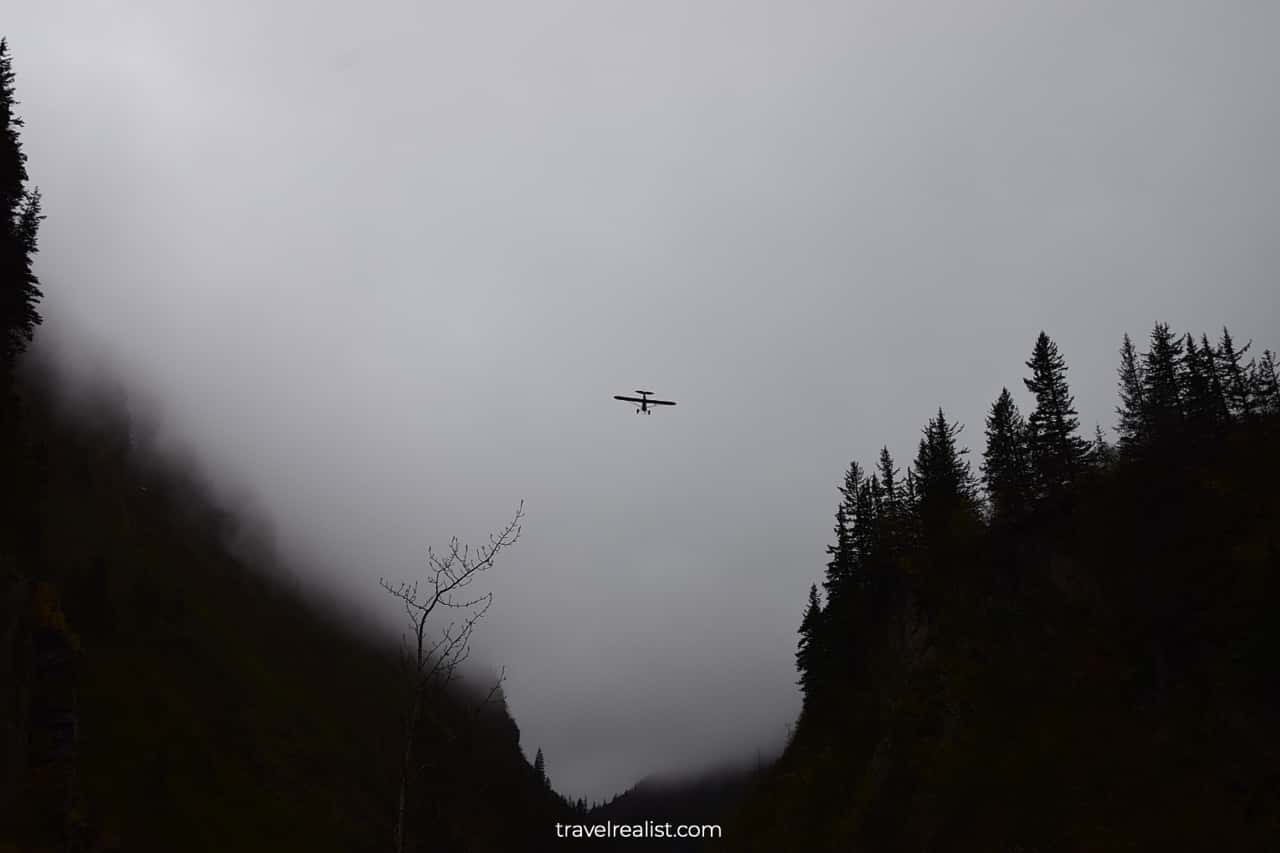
[796,323,1280,708]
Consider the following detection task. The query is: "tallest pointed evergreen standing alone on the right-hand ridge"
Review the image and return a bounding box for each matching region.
[1023,332,1089,496]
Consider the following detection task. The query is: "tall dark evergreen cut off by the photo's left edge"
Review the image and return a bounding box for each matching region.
[0,38,44,370]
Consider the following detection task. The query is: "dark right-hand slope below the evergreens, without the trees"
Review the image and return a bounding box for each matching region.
[723,418,1280,850]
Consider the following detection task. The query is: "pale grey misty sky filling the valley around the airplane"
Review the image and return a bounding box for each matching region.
[3,0,1280,797]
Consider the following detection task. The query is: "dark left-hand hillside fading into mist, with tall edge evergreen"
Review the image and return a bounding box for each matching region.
[0,42,568,853]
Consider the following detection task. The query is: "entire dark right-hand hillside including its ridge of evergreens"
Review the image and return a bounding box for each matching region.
[723,324,1280,850]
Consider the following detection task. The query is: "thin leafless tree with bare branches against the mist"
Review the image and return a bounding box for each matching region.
[378,501,525,853]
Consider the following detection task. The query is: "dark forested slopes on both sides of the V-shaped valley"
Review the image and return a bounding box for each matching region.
[0,28,1280,853]
